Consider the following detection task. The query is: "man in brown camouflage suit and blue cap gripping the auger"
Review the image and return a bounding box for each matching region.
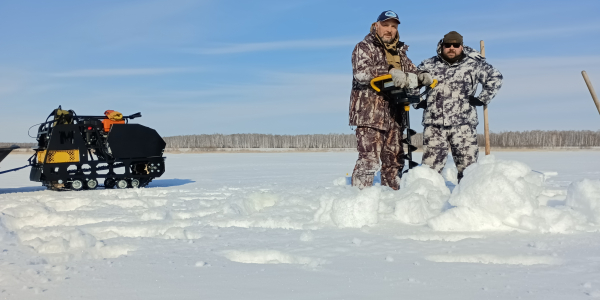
[350,11,432,190]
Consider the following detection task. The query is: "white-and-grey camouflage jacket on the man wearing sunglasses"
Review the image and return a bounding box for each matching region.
[418,40,502,126]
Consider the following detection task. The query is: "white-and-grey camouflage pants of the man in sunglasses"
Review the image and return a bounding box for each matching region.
[422,125,479,180]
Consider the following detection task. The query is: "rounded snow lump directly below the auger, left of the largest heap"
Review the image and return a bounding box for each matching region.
[394,166,450,224]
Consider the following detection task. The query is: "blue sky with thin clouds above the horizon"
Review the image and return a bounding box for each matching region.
[0,0,600,142]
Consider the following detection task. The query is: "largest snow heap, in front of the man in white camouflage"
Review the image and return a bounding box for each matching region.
[428,155,582,232]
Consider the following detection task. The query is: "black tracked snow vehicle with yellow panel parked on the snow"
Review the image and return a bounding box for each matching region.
[29,106,166,190]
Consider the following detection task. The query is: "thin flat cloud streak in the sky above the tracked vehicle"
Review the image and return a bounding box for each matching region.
[52,68,197,77]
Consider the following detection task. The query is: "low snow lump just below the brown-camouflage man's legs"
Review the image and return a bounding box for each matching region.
[314,186,382,228]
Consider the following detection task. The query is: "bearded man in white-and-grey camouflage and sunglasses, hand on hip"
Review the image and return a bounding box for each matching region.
[416,31,502,181]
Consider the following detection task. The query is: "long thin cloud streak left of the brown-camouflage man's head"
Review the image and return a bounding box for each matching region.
[183,38,360,55]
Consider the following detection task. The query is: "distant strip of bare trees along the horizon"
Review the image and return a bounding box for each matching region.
[164,130,600,149]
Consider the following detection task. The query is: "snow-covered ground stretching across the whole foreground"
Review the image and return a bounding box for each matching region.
[0,151,600,299]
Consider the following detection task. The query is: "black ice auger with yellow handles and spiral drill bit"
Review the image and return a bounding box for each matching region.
[371,74,438,175]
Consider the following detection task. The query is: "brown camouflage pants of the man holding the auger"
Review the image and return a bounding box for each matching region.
[352,122,404,190]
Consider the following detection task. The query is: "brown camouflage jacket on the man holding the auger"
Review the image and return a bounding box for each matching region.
[350,30,417,130]
